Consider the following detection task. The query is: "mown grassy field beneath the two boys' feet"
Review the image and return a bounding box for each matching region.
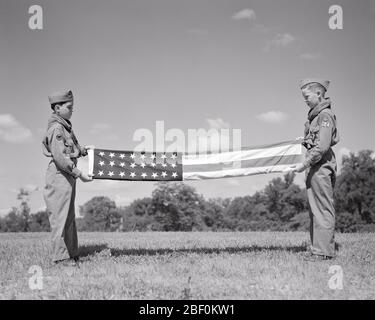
[0,232,375,299]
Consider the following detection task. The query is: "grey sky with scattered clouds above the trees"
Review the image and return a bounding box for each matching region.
[0,0,375,215]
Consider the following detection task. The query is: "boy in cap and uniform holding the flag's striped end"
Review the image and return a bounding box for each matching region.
[292,79,339,261]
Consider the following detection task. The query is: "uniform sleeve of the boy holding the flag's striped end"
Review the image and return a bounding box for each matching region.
[303,114,334,169]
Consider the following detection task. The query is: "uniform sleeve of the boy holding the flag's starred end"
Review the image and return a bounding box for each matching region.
[50,129,81,178]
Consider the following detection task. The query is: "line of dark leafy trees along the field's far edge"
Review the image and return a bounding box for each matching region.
[0,150,375,232]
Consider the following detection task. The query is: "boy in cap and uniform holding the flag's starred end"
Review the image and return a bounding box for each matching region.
[43,91,92,264]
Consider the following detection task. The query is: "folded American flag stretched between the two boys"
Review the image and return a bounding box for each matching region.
[89,140,302,181]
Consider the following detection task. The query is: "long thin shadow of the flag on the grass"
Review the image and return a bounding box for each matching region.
[111,245,306,257]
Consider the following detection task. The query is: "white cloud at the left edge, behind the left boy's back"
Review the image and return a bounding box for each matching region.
[0,114,32,143]
